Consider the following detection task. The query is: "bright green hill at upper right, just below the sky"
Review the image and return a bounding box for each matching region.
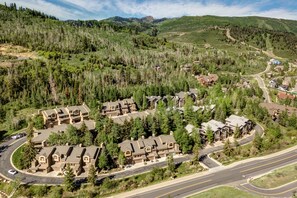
[159,16,297,59]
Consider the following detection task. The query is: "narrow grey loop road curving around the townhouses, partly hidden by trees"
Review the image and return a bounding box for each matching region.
[0,125,263,184]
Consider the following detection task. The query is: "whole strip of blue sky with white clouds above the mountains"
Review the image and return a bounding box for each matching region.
[0,0,297,20]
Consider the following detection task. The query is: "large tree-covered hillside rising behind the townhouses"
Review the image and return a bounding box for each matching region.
[0,4,296,133]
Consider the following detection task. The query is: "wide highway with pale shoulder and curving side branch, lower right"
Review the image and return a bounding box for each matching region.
[114,146,297,198]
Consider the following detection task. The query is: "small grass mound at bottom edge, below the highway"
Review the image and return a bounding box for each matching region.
[189,186,260,198]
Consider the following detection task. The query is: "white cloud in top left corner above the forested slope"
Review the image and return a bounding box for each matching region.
[0,0,83,19]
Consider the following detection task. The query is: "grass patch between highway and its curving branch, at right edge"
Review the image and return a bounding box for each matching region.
[251,164,297,188]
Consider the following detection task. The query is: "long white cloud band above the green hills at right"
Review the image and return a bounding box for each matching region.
[115,0,297,19]
